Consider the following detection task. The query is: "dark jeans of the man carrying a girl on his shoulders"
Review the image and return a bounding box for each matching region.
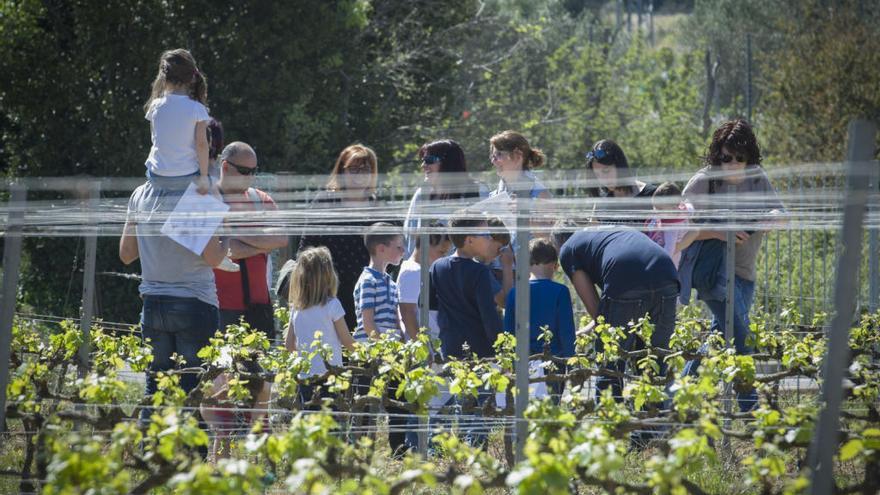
[141,295,219,404]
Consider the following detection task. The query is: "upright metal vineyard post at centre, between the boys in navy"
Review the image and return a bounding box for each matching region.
[514,190,532,462]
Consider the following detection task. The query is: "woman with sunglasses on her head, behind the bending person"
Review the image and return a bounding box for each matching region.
[586,139,657,226]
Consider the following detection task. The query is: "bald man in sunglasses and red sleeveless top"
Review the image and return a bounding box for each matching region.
[214,141,287,339]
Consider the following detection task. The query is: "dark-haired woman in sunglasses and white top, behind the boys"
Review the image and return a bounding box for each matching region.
[404,139,489,256]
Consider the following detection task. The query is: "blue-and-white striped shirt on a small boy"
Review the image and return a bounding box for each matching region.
[353,266,400,342]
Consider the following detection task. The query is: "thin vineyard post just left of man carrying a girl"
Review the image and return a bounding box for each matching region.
[77,181,101,378]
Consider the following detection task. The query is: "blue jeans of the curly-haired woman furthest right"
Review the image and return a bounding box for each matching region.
[684,277,758,411]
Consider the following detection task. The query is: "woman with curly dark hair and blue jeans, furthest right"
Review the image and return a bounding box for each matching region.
[680,119,783,410]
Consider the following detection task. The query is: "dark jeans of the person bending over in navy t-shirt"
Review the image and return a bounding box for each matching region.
[596,283,678,398]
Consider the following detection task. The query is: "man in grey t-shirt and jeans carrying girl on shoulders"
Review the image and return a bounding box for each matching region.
[119,175,228,402]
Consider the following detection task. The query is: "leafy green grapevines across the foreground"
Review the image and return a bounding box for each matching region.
[3,311,880,494]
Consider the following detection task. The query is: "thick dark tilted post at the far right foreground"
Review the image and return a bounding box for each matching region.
[809,120,877,495]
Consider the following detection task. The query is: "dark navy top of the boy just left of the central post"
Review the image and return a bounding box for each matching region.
[430,256,501,357]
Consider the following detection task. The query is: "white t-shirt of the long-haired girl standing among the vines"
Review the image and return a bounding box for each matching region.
[290,297,345,375]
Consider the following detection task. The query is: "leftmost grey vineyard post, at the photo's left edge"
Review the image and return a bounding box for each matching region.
[0,184,27,431]
